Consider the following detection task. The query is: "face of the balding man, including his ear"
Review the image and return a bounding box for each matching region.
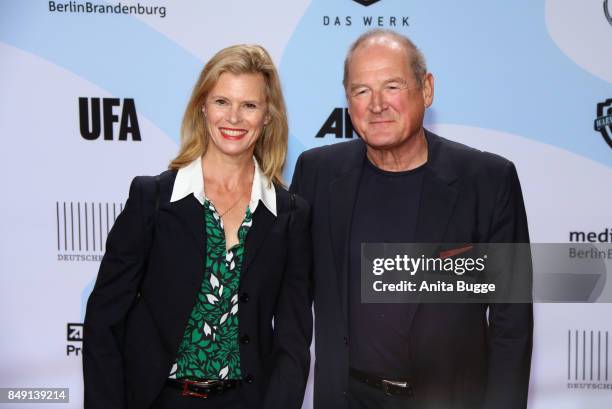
[346,40,433,150]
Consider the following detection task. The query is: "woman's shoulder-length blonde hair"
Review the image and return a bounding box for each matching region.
[169,44,289,185]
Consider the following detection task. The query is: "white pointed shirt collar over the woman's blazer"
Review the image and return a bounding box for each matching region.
[170,156,276,216]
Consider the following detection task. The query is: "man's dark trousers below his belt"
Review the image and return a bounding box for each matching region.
[349,377,417,409]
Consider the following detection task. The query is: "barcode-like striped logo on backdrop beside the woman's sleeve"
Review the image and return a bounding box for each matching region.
[55,202,123,262]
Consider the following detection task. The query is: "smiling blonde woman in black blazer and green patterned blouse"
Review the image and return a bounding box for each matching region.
[83,45,312,409]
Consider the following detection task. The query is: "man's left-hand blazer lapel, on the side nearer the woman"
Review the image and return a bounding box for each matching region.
[329,143,365,317]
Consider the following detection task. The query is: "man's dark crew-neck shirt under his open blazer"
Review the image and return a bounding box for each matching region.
[348,155,427,379]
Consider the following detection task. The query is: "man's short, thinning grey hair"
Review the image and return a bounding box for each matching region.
[342,29,427,89]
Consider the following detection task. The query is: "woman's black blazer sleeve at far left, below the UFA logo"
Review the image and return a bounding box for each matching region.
[83,177,152,409]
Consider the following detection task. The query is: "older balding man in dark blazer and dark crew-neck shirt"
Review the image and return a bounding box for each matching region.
[292,30,533,409]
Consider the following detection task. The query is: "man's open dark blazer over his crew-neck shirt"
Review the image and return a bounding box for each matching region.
[291,131,533,409]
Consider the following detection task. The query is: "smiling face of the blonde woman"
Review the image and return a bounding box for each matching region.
[202,72,270,157]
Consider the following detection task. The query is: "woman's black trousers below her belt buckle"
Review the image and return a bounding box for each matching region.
[151,386,247,409]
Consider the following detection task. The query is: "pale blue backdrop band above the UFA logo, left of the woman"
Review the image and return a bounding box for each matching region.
[0,0,197,143]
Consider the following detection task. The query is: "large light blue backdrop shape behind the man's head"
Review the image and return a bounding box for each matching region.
[280,0,612,180]
